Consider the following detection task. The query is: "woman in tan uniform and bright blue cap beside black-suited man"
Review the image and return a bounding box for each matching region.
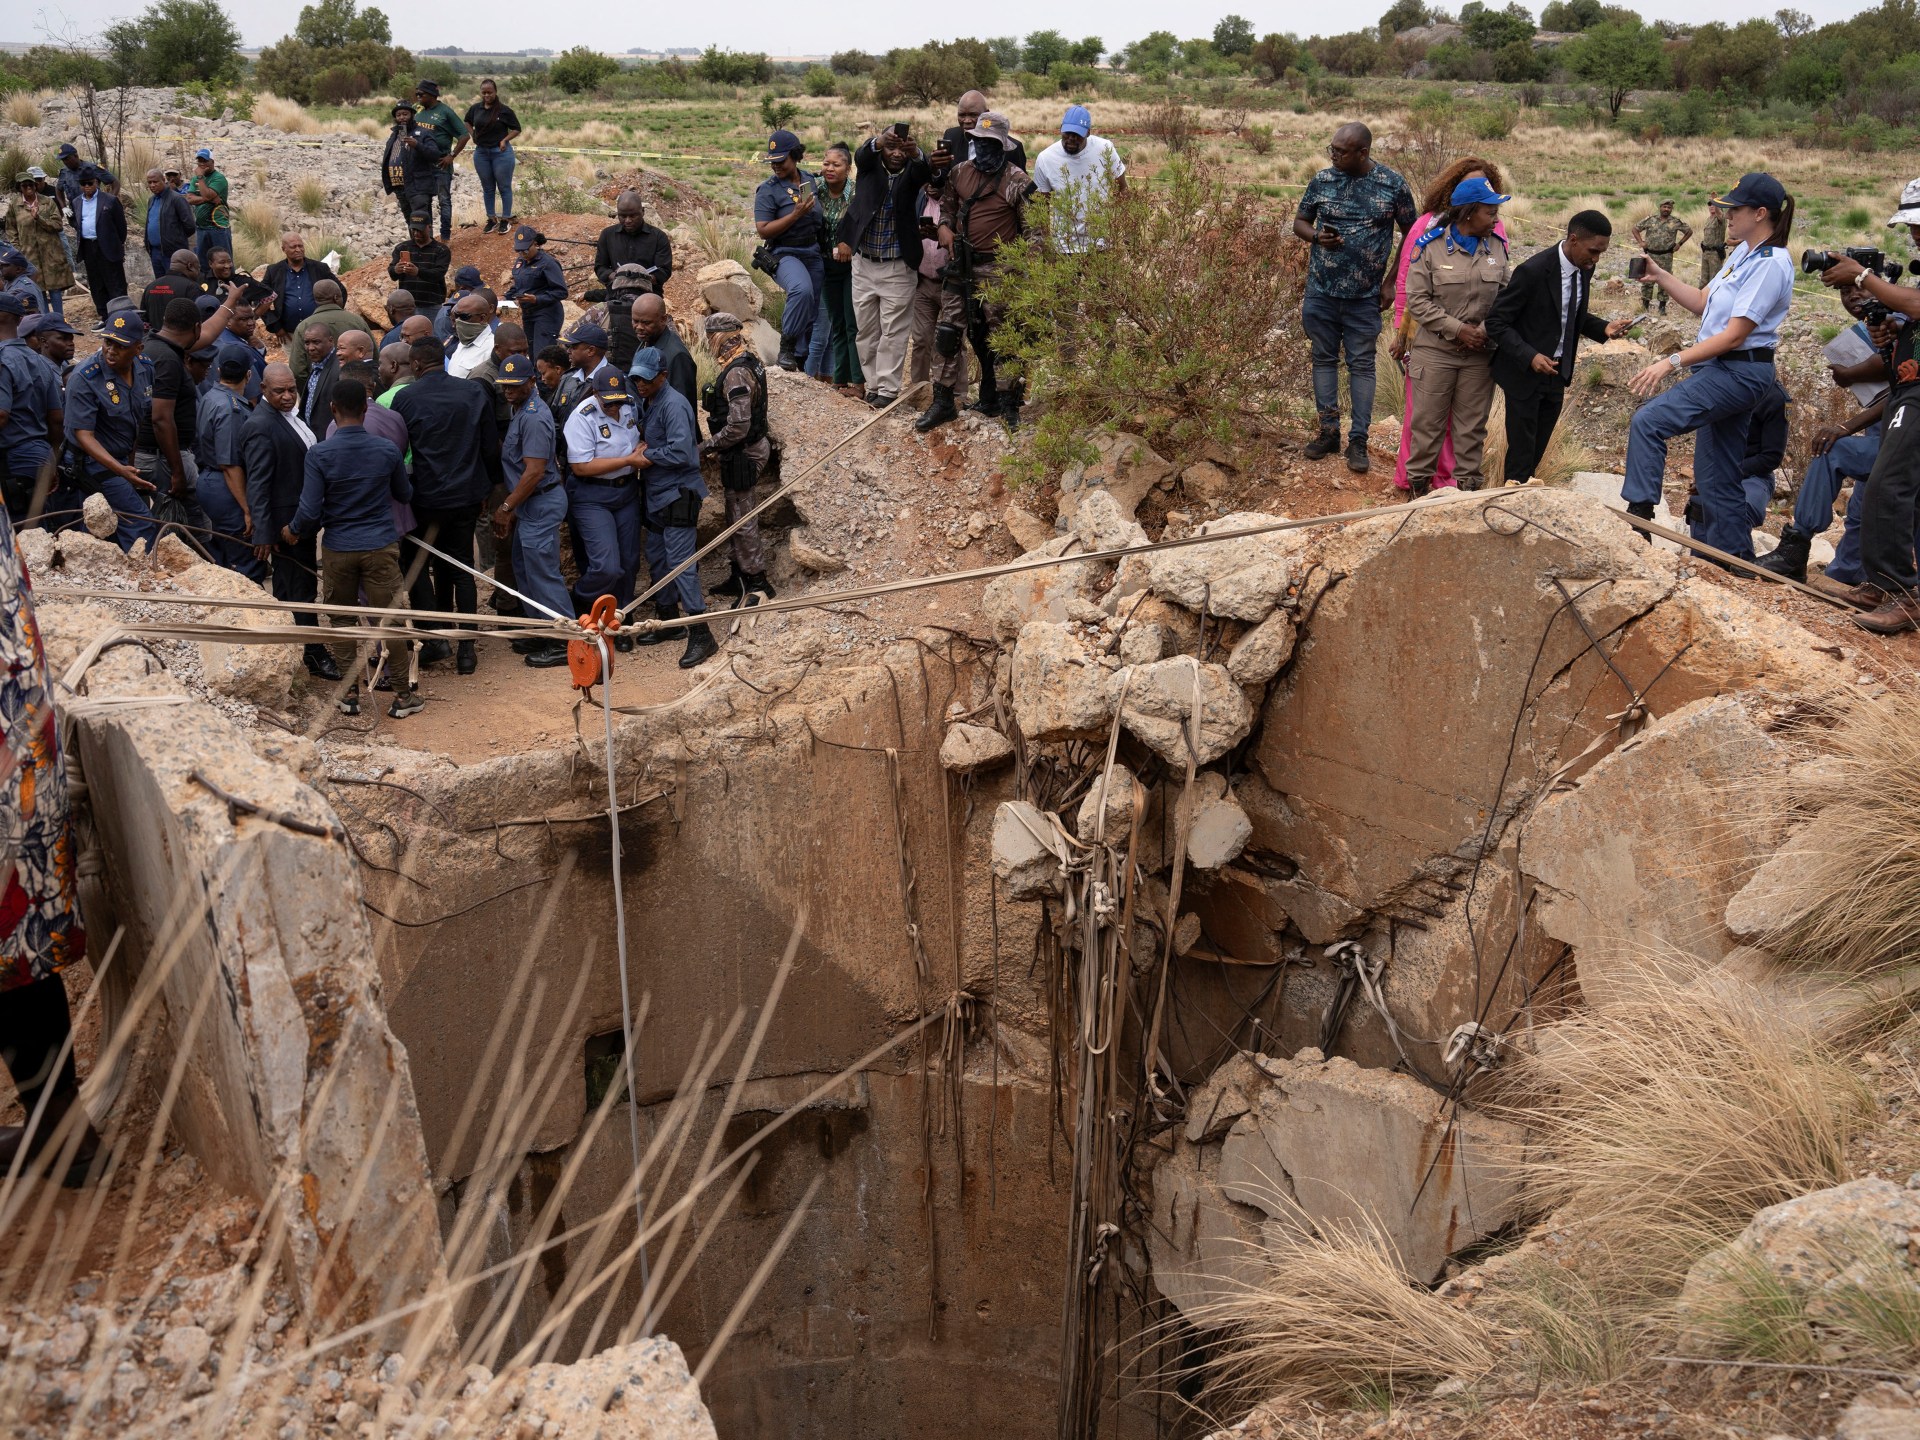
[1407,175,1511,497]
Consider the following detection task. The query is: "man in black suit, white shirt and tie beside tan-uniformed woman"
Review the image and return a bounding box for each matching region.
[1486,209,1632,486]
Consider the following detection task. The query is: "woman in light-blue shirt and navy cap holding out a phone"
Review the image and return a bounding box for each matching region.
[1620,171,1793,561]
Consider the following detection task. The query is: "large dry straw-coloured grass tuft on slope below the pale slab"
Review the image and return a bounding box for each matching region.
[1513,977,1872,1313]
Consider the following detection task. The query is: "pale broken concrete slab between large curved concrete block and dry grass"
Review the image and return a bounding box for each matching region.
[1521,699,1780,1004]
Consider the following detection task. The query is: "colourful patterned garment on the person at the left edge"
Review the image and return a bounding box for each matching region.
[0,511,86,991]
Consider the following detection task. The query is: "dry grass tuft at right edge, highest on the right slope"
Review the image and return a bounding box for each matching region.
[1766,695,1920,975]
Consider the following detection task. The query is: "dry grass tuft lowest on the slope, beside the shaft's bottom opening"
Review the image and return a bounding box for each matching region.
[1188,1215,1503,1413]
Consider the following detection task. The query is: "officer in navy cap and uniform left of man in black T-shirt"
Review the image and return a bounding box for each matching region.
[65,309,159,551]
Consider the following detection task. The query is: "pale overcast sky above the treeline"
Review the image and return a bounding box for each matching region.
[11,0,1868,54]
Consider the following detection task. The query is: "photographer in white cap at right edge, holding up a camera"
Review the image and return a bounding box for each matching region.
[1820,180,1920,636]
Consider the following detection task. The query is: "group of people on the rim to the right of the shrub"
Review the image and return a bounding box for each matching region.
[1294,125,1920,634]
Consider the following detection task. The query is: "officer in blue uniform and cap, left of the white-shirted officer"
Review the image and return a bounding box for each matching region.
[493,355,578,670]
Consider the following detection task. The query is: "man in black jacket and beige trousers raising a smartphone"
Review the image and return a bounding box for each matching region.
[833,121,933,409]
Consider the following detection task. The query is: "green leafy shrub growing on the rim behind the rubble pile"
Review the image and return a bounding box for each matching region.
[993,157,1306,478]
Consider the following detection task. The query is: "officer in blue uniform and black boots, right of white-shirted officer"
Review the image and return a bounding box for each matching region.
[634,346,720,670]
